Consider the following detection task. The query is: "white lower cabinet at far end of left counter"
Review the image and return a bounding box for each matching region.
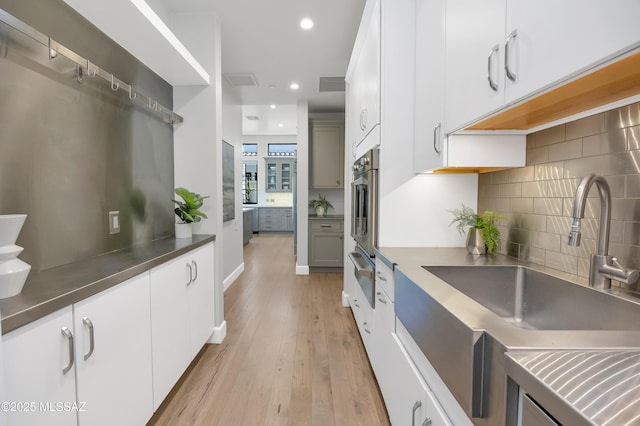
[150,240,214,410]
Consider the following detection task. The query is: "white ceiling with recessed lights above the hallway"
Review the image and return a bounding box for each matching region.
[148,0,365,112]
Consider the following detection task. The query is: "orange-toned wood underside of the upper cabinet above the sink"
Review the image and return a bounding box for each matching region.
[467,53,640,130]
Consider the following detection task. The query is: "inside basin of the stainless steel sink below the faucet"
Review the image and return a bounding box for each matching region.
[423,266,640,330]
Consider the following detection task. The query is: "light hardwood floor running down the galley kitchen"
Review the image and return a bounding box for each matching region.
[149,235,389,426]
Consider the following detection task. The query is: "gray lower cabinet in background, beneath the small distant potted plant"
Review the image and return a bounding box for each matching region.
[309,216,344,268]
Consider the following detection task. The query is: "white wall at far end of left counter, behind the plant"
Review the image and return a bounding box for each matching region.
[168,13,226,340]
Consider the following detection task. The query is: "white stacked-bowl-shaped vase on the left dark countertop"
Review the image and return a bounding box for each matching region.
[0,214,31,299]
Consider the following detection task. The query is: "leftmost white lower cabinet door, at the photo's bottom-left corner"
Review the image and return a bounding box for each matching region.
[3,306,77,426]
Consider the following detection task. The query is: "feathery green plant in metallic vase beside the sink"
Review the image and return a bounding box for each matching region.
[449,204,506,255]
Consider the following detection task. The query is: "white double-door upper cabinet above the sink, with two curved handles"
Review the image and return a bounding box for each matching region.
[445,0,640,133]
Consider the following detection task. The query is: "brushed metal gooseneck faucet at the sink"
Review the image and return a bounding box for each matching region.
[569,174,640,289]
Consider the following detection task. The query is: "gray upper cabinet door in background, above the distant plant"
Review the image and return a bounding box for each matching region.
[310,123,344,188]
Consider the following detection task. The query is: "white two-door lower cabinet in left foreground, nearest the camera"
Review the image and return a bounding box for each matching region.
[3,272,153,426]
